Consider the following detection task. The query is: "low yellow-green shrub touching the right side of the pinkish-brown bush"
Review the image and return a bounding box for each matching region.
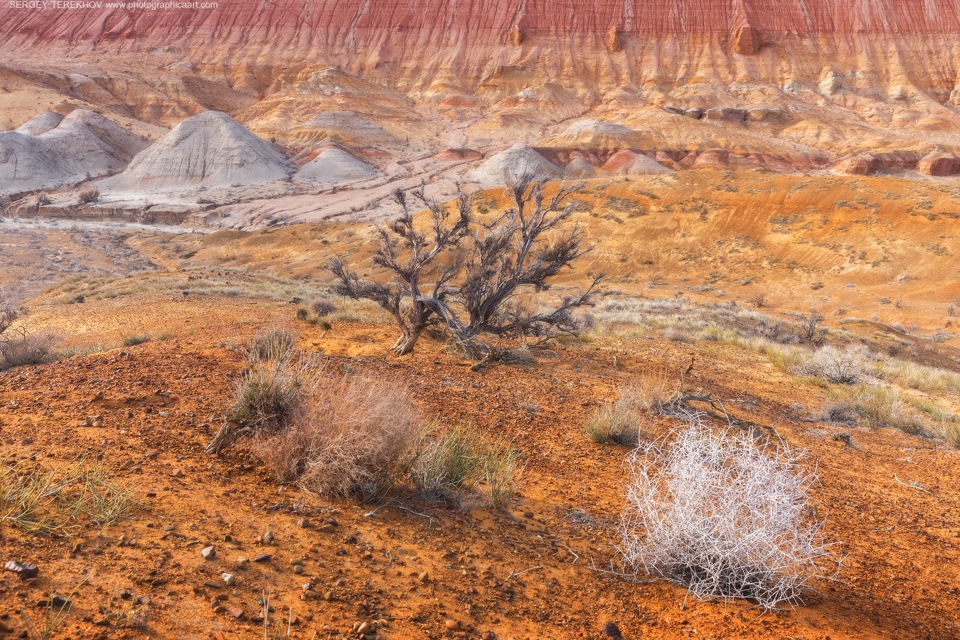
[410,427,483,500]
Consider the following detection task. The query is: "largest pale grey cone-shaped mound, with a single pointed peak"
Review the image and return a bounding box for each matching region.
[103,111,293,191]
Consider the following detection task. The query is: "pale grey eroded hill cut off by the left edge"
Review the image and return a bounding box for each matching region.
[0,109,146,195]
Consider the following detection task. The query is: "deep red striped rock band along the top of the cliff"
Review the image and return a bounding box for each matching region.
[0,0,960,48]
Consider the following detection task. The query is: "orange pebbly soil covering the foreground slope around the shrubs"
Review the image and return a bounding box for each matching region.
[0,298,960,640]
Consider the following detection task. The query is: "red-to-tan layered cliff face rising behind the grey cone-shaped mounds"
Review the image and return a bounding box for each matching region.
[0,0,960,182]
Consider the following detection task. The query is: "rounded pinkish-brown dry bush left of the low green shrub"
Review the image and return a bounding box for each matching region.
[255,370,420,500]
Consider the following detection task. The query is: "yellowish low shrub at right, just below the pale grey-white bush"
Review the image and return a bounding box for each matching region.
[819,383,926,435]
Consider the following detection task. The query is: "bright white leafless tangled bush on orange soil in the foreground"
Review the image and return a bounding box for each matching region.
[619,423,830,608]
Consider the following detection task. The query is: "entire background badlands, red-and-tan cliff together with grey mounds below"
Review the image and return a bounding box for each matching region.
[0,0,960,226]
